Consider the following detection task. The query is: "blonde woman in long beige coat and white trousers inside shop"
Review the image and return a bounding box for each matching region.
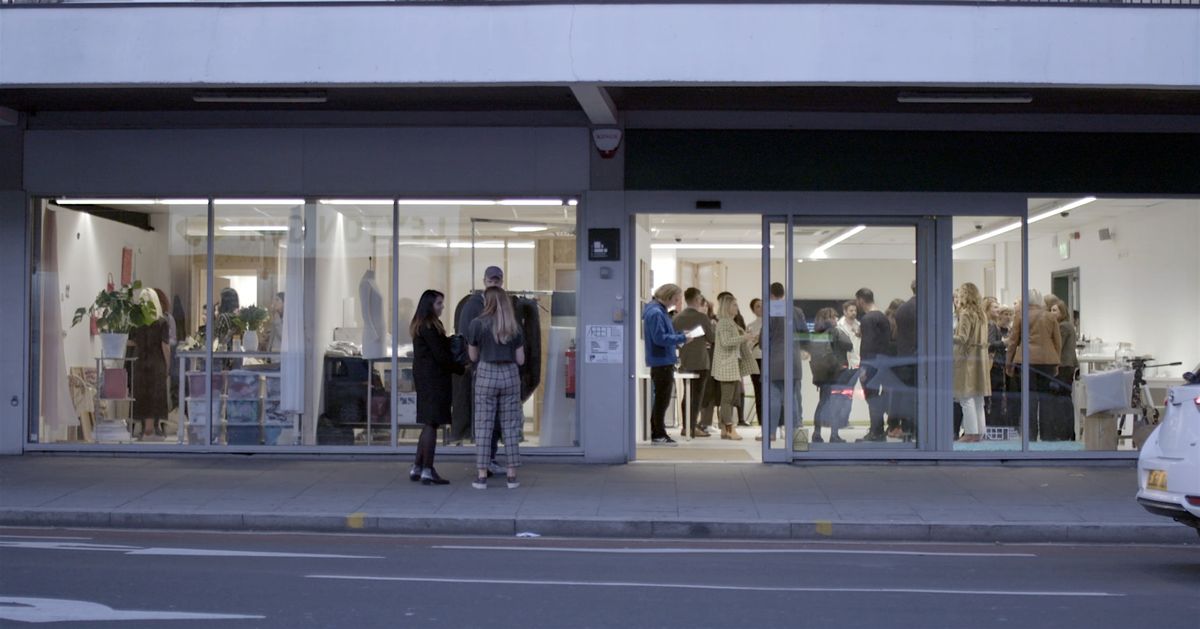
[954,282,991,443]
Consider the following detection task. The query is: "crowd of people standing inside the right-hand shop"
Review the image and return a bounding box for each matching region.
[642,281,1078,445]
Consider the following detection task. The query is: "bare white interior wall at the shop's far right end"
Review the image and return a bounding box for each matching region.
[1008,202,1200,373]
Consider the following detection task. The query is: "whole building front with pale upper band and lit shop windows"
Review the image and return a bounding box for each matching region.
[0,2,1200,462]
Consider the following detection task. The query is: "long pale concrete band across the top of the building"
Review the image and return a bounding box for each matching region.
[0,4,1200,88]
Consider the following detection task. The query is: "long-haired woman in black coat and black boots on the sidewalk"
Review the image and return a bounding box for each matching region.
[408,290,463,485]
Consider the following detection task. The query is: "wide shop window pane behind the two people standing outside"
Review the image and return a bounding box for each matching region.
[397,199,580,447]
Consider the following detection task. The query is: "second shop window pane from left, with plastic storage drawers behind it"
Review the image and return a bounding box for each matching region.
[208,199,307,445]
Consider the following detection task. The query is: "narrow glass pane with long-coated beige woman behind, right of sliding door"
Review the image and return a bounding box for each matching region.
[947,216,1022,451]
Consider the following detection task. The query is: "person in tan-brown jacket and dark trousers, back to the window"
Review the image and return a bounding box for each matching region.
[1006,289,1062,442]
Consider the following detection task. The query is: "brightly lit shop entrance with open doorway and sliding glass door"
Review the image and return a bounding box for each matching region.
[634,214,932,462]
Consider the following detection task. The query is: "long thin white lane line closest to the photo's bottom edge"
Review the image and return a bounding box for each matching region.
[305,575,1124,598]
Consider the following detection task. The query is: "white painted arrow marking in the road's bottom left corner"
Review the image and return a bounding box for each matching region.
[0,597,266,623]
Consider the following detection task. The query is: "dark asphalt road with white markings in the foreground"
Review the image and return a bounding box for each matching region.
[0,528,1200,629]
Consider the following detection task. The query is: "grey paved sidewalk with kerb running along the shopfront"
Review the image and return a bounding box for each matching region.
[0,455,1200,544]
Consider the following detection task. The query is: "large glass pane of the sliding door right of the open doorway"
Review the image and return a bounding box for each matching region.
[791,223,922,450]
